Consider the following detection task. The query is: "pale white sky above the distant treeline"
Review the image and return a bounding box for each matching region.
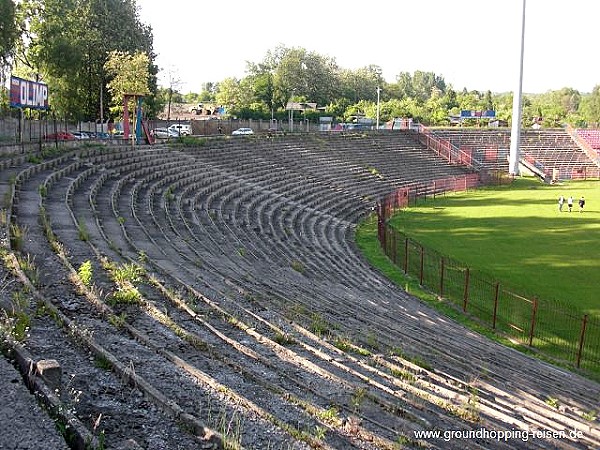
[137,0,600,94]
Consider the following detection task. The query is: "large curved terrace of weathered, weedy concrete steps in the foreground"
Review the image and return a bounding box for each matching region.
[0,131,600,449]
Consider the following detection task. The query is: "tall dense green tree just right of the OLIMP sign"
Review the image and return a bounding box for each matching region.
[22,0,157,120]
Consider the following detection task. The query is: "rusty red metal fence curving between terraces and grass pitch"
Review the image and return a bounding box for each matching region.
[377,175,600,371]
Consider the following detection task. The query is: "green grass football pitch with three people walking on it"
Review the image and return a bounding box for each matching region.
[391,178,600,317]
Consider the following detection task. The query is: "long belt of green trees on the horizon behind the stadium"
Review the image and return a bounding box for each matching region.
[142,43,598,126]
